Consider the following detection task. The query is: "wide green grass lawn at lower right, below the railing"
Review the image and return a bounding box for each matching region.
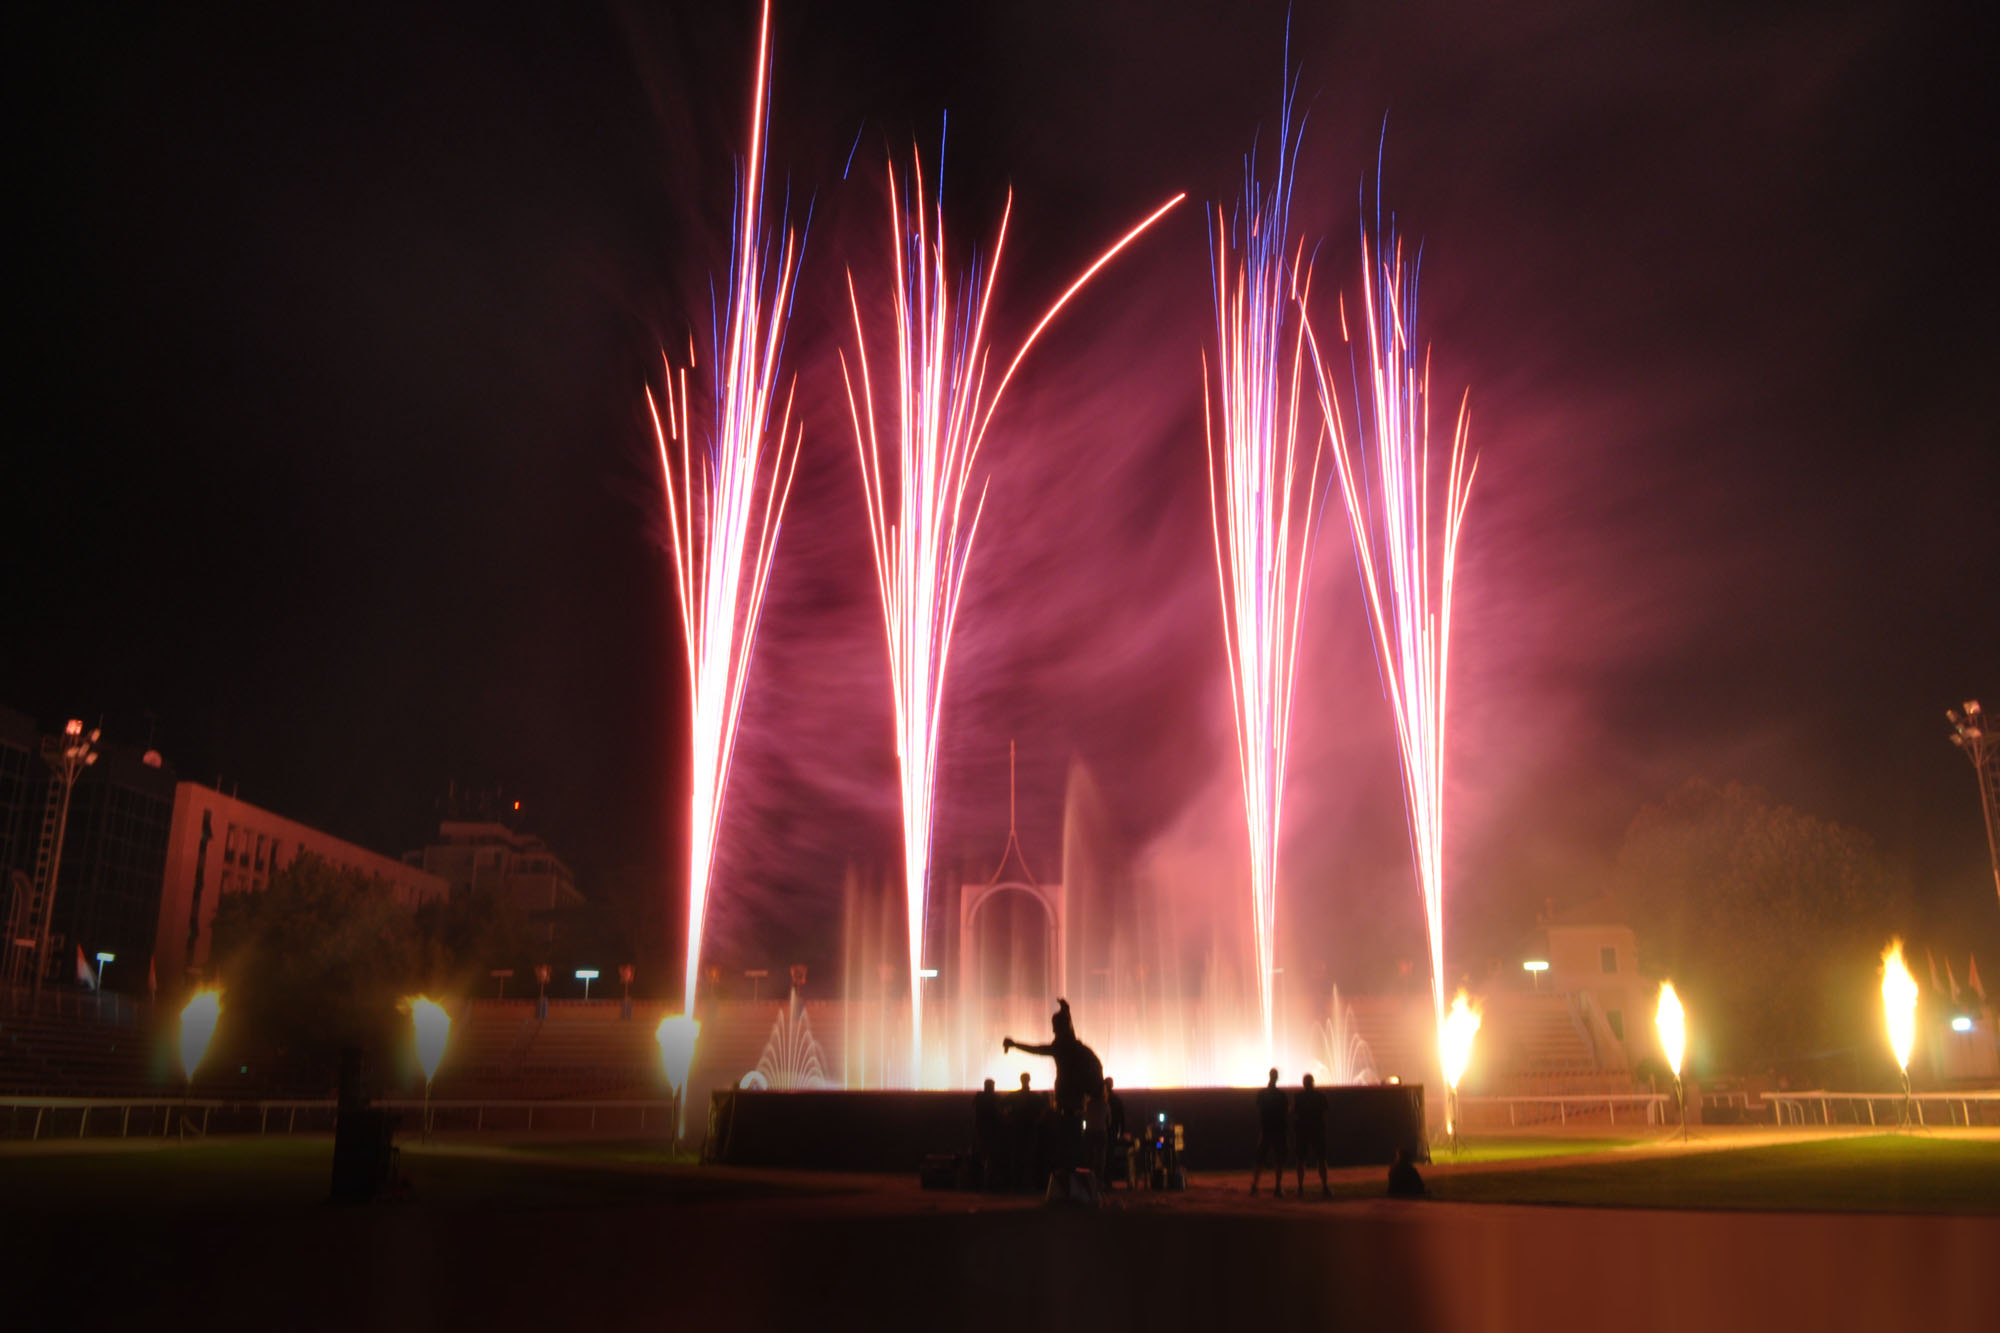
[1430,1135,2000,1213]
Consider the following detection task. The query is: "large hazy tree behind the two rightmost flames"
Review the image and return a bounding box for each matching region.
[1618,779,1908,1071]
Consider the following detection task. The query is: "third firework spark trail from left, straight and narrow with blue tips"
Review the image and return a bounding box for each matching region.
[1202,72,1320,1055]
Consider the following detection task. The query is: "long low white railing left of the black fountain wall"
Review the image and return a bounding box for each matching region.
[0,1097,674,1139]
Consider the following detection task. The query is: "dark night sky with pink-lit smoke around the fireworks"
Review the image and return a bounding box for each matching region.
[0,0,2000,984]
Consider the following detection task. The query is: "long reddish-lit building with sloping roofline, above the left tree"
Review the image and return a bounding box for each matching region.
[154,783,448,983]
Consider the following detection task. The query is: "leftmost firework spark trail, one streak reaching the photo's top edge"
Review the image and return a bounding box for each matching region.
[646,0,804,1015]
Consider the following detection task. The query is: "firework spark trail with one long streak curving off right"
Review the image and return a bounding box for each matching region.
[840,145,1184,1085]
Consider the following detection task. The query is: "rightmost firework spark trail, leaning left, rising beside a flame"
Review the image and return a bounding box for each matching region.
[1300,213,1478,1088]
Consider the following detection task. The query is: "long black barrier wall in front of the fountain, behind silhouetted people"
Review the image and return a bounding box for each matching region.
[704,1083,1430,1171]
